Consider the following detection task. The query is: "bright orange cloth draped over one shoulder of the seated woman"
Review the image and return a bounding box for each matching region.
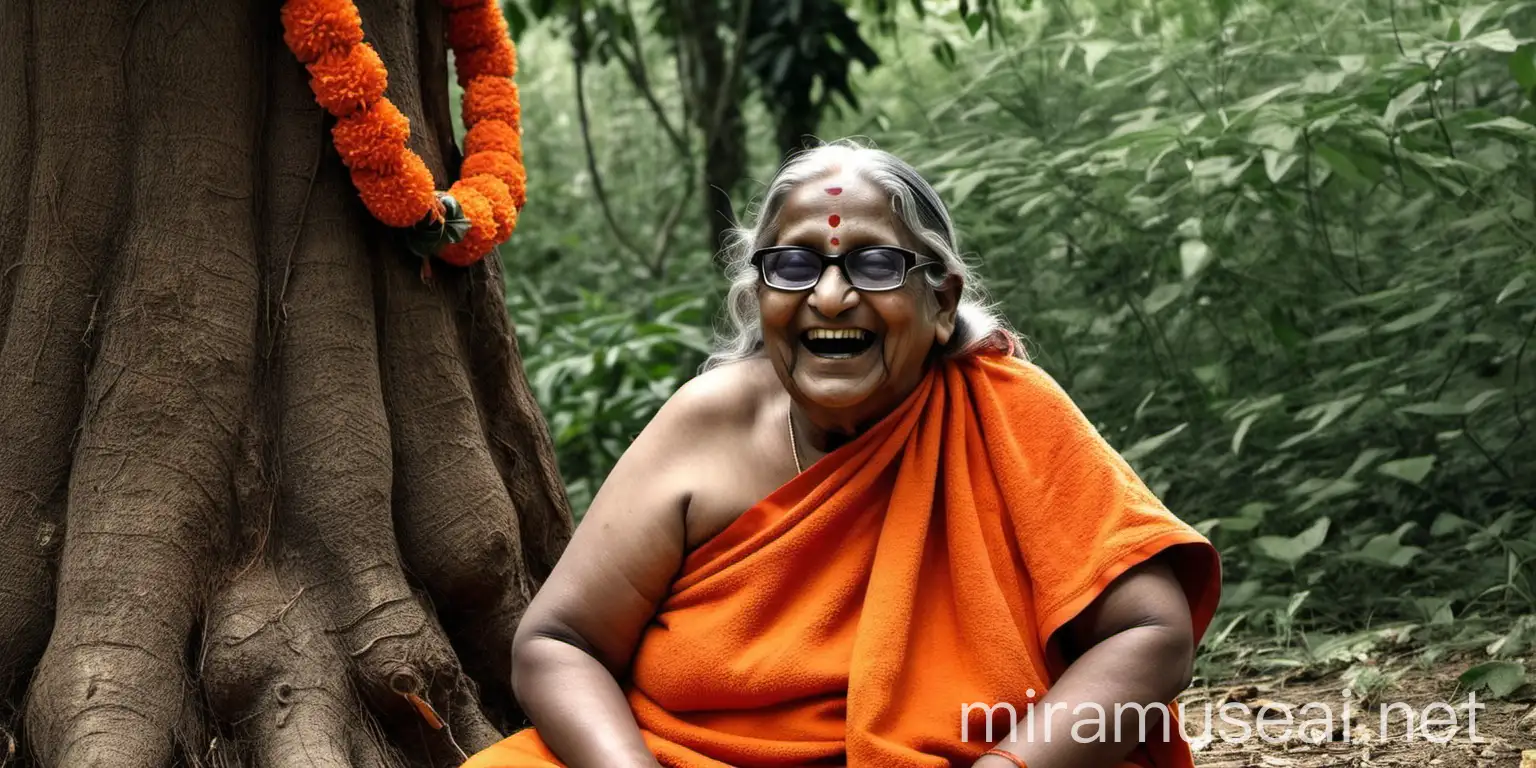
[465,355,1220,768]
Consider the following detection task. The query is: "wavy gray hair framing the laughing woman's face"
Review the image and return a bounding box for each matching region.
[702,140,1023,370]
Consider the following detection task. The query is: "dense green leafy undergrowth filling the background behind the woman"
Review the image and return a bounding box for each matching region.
[507,0,1536,642]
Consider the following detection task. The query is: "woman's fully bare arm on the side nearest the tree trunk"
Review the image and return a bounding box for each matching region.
[513,379,730,768]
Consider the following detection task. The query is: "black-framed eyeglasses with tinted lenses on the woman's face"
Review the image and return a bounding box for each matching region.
[753,246,938,292]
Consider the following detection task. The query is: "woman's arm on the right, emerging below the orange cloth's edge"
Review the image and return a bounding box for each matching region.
[975,559,1195,768]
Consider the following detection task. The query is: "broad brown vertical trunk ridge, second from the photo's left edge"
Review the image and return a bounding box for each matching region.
[28,5,260,768]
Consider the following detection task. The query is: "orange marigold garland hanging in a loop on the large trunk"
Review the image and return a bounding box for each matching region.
[281,0,527,266]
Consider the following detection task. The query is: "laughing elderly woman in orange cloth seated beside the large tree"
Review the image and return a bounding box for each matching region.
[468,144,1220,768]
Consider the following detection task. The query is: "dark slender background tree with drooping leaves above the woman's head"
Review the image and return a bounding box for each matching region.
[537,0,891,261]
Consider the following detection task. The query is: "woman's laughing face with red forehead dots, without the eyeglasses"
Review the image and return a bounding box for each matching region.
[757,174,960,433]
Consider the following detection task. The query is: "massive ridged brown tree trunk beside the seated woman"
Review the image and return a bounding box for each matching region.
[0,0,571,768]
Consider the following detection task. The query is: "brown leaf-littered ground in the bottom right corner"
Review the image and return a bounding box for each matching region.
[1183,657,1536,768]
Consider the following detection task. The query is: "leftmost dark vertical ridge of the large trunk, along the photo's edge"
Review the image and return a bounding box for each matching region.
[0,3,129,731]
